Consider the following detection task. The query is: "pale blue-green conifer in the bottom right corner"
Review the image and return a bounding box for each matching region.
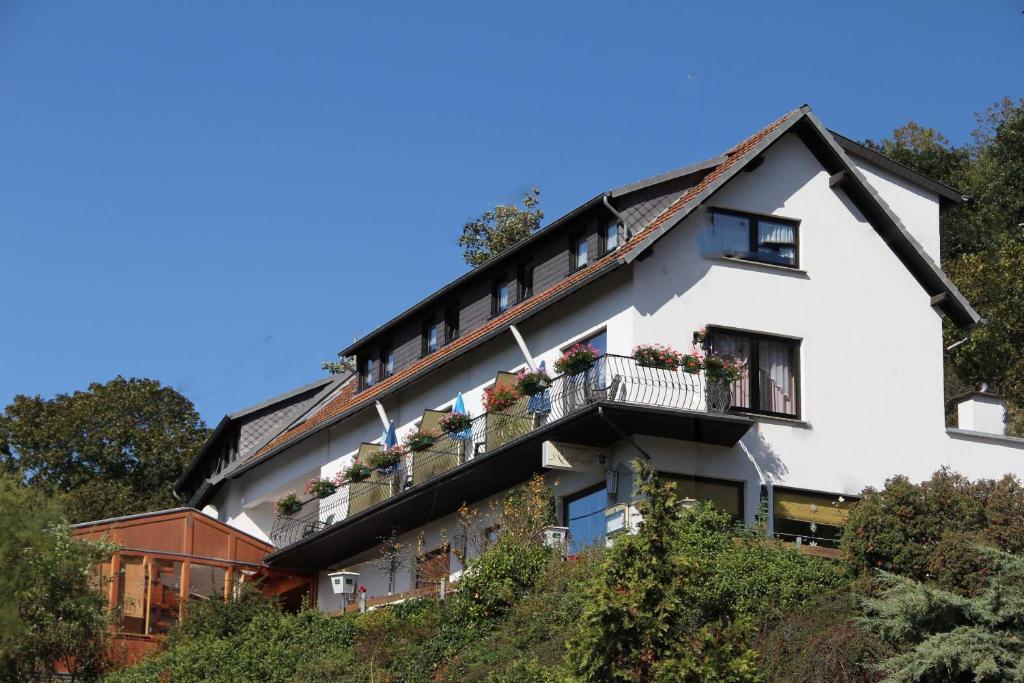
[864,551,1024,683]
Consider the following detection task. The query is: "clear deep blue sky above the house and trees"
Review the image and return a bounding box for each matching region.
[0,0,1024,423]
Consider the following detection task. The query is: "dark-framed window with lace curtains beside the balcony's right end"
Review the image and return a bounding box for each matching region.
[710,330,800,418]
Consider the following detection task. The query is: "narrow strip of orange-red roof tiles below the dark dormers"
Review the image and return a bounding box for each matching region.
[247,113,793,462]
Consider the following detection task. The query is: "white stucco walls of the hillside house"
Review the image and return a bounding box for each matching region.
[203,129,1024,610]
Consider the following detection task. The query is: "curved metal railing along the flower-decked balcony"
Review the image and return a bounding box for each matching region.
[270,354,729,548]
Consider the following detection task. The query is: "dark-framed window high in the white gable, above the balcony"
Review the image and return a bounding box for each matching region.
[700,209,800,268]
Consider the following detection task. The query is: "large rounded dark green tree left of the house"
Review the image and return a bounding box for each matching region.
[0,377,209,521]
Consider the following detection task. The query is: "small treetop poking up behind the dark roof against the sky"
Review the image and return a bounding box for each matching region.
[459,188,544,266]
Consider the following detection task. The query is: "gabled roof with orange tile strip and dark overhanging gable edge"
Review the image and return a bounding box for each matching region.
[230,104,979,477]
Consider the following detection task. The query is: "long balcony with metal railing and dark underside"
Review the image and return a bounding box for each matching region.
[265,354,753,569]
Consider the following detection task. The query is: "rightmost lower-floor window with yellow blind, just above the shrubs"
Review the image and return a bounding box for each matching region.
[772,486,856,547]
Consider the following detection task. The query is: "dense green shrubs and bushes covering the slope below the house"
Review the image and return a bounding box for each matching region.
[108,465,1024,683]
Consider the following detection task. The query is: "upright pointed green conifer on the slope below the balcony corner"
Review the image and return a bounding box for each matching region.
[568,463,759,681]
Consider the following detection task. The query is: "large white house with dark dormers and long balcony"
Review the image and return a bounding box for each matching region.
[176,106,1024,609]
